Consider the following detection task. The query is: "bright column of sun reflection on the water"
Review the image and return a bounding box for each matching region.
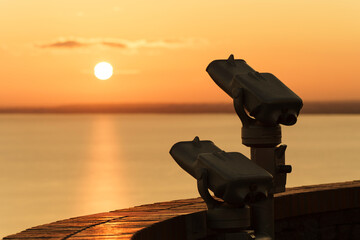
[78,115,130,213]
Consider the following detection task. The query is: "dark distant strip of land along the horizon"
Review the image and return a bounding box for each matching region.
[0,100,360,114]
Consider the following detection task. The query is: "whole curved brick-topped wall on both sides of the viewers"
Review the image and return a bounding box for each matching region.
[4,181,360,240]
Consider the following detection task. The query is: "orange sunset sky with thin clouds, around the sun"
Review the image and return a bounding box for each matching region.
[0,0,360,107]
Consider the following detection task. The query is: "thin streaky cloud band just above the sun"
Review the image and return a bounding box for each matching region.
[35,38,207,49]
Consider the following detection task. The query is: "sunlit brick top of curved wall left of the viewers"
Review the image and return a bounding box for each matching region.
[4,198,206,240]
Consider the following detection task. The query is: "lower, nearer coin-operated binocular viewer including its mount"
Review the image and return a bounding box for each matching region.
[170,137,272,239]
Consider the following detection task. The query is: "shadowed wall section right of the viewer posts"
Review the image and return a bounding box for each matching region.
[275,181,360,240]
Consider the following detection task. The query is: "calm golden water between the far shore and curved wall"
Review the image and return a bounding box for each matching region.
[0,114,360,237]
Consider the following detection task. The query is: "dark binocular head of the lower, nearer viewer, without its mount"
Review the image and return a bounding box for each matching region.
[170,138,273,205]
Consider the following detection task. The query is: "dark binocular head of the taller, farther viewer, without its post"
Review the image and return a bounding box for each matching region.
[206,55,303,125]
